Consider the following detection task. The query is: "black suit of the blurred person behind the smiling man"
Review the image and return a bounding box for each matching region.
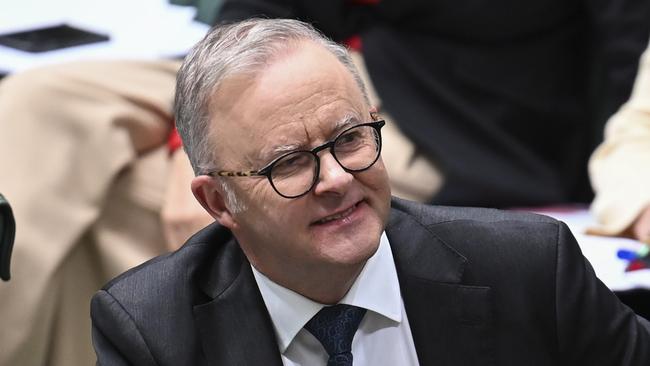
[218,0,650,207]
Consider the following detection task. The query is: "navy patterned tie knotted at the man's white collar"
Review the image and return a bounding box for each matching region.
[305,304,366,366]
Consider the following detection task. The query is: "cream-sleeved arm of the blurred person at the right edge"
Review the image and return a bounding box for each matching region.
[590,45,650,244]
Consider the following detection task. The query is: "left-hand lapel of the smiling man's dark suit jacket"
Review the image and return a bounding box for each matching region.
[194,240,282,366]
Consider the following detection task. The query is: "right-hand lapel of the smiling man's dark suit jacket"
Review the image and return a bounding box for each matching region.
[386,206,494,366]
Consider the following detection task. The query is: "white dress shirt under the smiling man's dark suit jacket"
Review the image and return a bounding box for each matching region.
[251,232,419,366]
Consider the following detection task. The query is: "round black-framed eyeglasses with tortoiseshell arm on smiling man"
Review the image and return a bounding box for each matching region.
[206,120,386,198]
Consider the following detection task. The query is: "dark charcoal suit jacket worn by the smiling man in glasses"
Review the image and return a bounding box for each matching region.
[91,199,650,366]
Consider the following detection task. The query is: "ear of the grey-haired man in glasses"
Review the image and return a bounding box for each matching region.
[192,175,235,230]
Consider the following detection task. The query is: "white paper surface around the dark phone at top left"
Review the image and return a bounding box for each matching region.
[0,0,208,72]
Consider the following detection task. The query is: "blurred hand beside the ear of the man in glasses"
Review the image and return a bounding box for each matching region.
[160,149,214,250]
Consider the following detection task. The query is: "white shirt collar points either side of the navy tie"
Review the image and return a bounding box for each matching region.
[251,232,402,353]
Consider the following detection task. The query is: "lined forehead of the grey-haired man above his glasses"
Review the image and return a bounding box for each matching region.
[211,43,365,163]
